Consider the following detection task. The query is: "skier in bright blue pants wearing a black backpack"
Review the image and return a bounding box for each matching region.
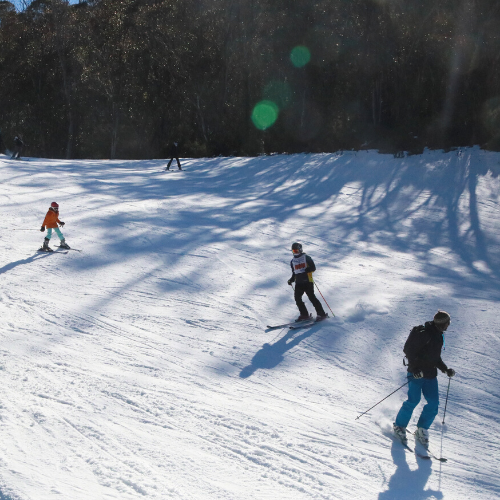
[393,311,455,447]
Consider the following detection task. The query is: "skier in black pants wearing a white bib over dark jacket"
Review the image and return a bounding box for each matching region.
[288,243,328,321]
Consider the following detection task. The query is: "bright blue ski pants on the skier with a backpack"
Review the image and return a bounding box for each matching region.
[394,373,439,429]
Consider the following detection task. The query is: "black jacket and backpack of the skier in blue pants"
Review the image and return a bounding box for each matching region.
[403,321,448,378]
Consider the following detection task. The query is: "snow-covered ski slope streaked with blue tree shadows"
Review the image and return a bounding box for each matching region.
[0,148,500,500]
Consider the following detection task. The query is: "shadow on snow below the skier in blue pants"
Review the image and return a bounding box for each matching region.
[378,441,443,500]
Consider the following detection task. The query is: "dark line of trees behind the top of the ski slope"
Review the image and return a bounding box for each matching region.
[0,0,500,158]
